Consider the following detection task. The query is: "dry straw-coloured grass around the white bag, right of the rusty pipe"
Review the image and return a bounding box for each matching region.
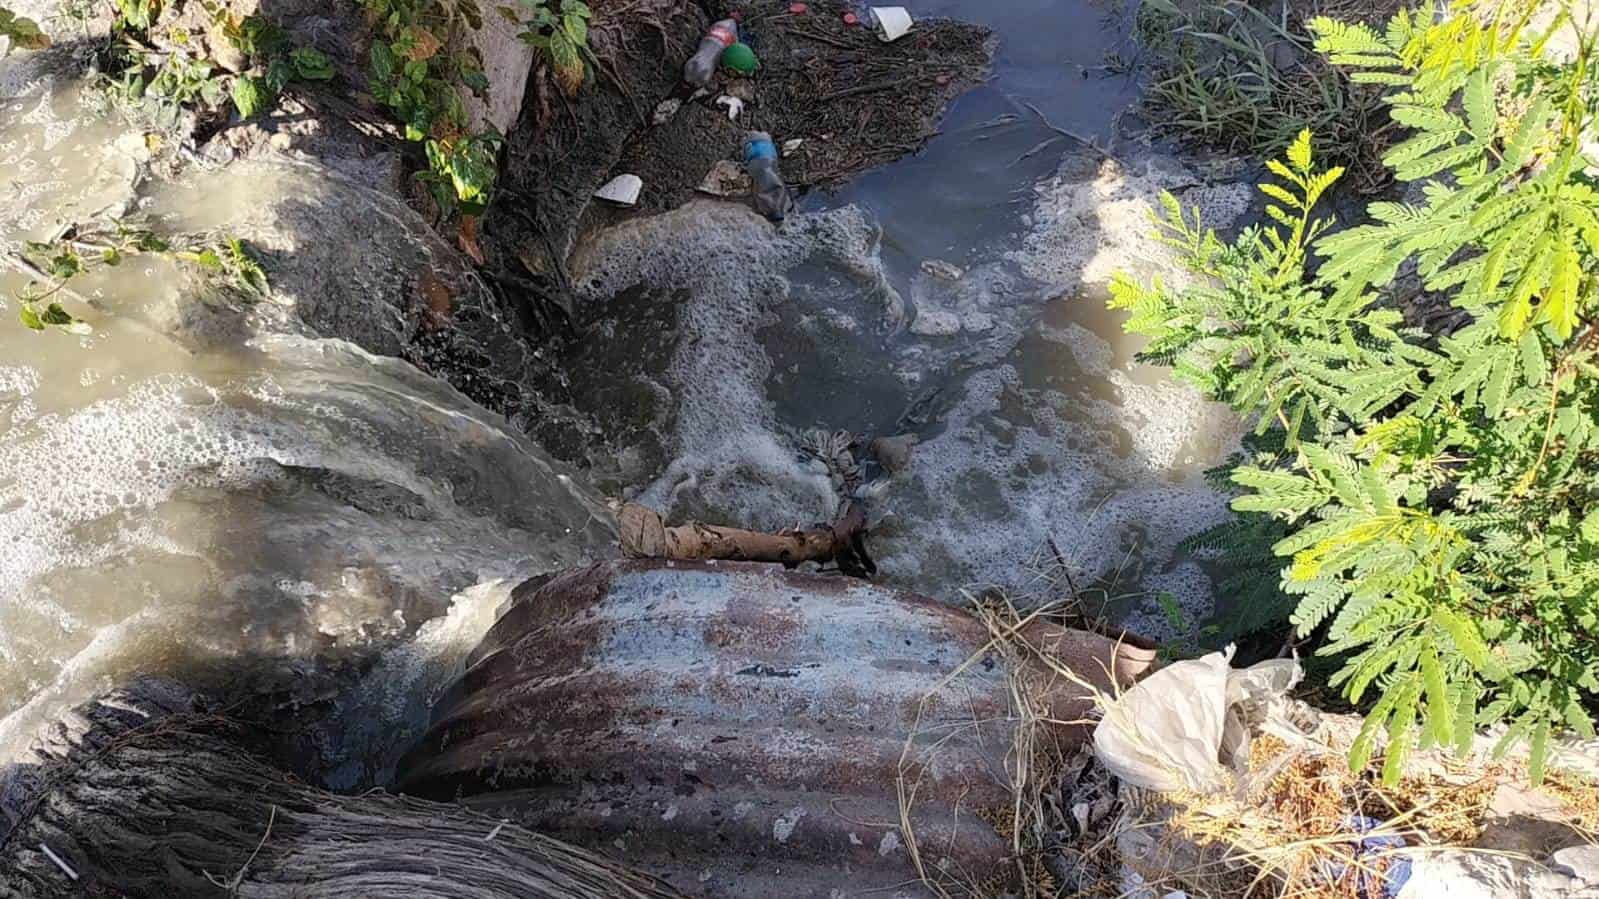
[900,597,1579,899]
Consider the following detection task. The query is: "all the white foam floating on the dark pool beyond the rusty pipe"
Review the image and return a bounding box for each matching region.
[574,173,1234,630]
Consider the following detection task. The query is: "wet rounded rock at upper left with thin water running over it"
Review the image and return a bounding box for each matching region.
[155,158,556,421]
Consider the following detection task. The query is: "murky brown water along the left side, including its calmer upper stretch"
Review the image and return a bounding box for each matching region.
[0,75,604,776]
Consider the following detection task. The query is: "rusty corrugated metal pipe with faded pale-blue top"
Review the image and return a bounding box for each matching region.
[401,561,1153,899]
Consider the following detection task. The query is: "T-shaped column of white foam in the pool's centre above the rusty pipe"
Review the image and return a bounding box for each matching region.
[572,200,897,528]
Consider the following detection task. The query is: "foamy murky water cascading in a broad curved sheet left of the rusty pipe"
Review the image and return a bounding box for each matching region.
[0,338,607,758]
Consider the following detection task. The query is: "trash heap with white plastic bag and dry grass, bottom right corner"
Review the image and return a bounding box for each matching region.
[1043,649,1599,899]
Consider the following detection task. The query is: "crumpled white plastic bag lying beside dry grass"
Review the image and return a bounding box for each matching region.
[1094,646,1303,793]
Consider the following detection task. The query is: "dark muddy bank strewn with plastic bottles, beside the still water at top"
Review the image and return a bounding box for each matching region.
[484,0,993,318]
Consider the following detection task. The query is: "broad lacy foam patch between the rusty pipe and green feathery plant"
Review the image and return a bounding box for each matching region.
[875,356,1226,606]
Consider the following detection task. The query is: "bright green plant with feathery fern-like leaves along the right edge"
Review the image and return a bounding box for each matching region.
[1111,0,1599,781]
